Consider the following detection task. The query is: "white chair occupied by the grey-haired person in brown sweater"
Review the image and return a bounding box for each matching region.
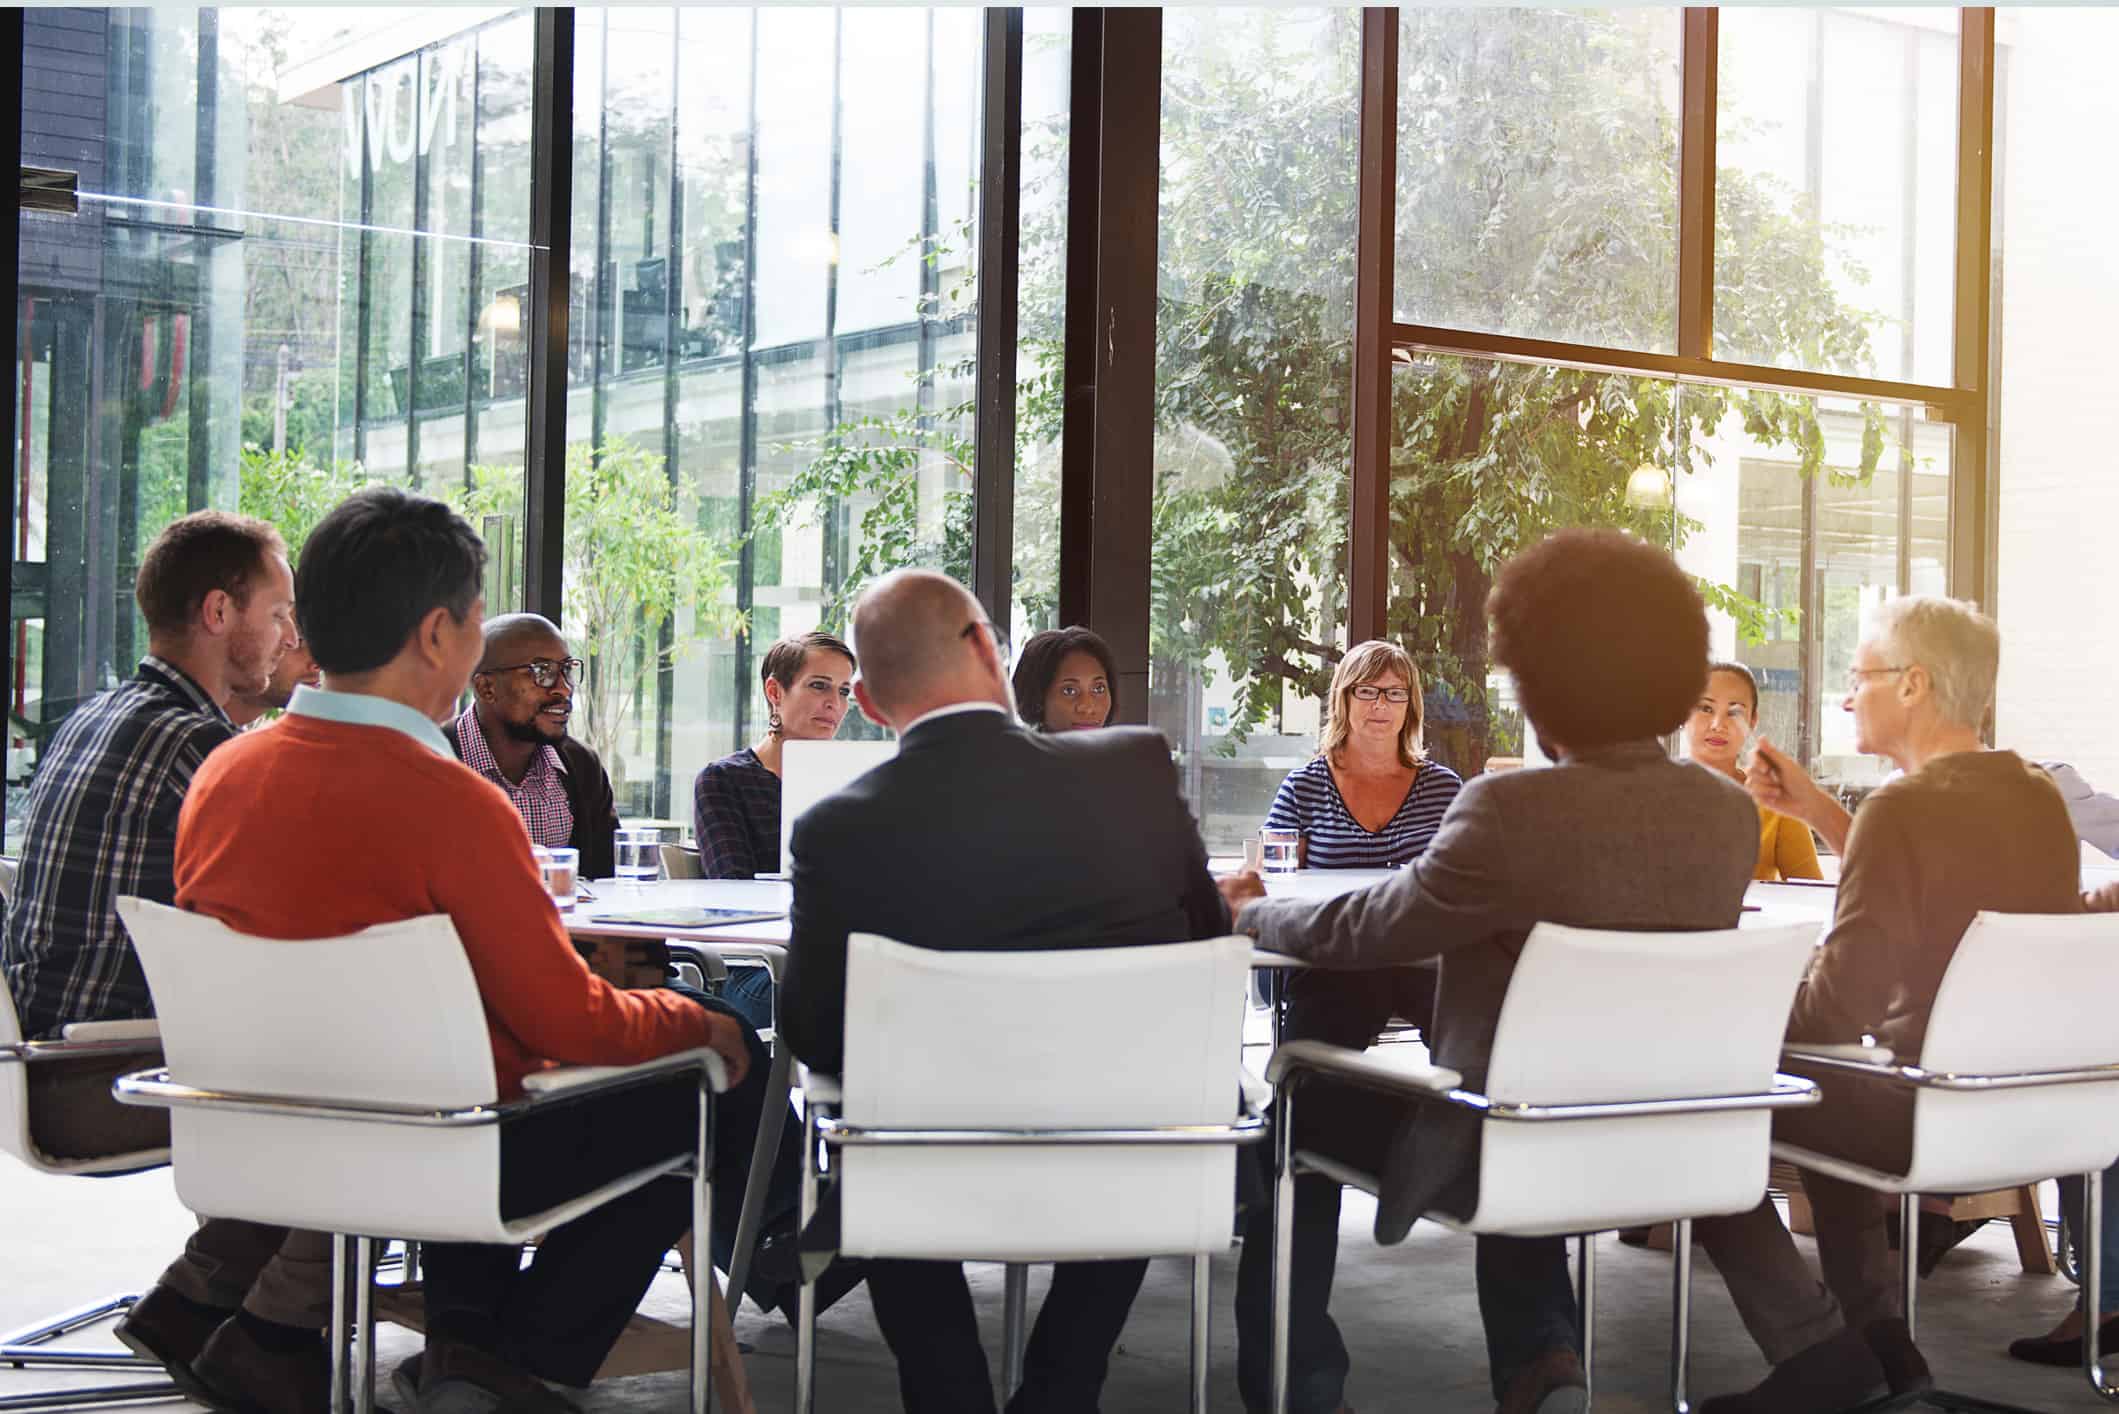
[1774,914,2119,1414]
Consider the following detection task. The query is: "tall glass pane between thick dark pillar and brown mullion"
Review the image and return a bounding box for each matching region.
[1148,8,1360,852]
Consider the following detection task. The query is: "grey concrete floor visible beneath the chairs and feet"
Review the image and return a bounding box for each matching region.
[0,1162,2106,1414]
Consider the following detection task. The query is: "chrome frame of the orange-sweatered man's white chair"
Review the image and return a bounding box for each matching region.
[114,1056,714,1414]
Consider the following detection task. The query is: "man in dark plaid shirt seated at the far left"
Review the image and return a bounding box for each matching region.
[0,511,295,1157]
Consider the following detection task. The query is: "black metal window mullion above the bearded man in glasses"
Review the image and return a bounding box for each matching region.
[523,6,574,623]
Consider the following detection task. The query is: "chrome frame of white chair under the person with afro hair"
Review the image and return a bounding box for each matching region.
[1267,1041,1820,1414]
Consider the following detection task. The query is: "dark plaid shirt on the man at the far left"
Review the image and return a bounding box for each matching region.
[0,657,235,1037]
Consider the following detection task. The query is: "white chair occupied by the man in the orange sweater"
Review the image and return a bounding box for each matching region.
[119,899,727,1414]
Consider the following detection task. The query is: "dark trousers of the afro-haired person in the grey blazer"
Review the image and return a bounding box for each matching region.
[1235,967,1579,1414]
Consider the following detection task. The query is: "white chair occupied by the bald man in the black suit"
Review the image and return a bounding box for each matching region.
[795,933,1265,1414]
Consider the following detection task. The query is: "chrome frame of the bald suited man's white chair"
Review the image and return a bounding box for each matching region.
[795,1077,1265,1414]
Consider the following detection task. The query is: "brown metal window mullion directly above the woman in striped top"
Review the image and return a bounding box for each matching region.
[1346,6,1399,644]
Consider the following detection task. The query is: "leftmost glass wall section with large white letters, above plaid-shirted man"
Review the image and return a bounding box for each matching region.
[6,6,530,848]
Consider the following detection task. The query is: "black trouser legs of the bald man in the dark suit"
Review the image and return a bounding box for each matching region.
[869,1259,1148,1414]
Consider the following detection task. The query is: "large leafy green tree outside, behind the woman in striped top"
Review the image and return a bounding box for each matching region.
[759,8,1886,767]
